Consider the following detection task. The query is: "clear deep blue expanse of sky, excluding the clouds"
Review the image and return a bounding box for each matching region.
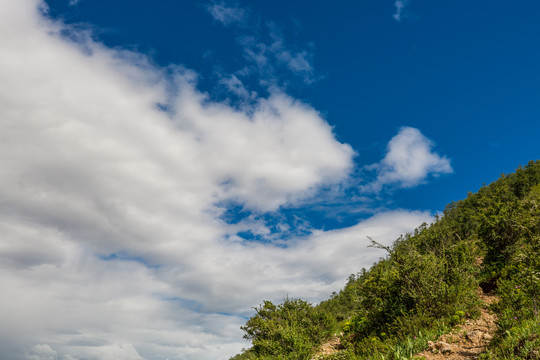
[48,0,540,214]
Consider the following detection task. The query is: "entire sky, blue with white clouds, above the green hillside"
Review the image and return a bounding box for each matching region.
[0,0,540,360]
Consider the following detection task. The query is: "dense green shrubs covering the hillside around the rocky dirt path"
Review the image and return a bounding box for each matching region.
[231,161,540,360]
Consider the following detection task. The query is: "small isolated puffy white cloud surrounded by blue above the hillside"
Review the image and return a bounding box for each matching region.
[364,127,453,191]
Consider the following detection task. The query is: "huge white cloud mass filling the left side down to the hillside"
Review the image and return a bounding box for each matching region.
[0,0,436,360]
